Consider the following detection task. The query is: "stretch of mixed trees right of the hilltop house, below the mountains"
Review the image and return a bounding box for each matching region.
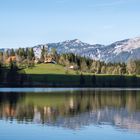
[58,53,140,75]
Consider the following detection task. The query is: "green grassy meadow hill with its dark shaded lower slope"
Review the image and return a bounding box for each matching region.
[17,64,140,87]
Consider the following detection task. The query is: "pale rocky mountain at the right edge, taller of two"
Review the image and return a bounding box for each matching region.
[101,37,140,62]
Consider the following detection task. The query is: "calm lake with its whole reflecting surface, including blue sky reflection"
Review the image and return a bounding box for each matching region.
[0,88,140,140]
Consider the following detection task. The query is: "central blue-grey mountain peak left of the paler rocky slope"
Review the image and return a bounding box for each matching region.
[48,39,105,59]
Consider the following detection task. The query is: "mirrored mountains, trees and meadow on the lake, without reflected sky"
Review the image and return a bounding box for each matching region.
[0,91,140,133]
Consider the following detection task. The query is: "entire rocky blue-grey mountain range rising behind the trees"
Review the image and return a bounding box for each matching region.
[0,37,140,62]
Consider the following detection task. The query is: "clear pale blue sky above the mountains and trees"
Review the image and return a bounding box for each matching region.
[0,0,140,48]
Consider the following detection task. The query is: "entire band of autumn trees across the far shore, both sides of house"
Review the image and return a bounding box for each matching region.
[0,47,140,75]
